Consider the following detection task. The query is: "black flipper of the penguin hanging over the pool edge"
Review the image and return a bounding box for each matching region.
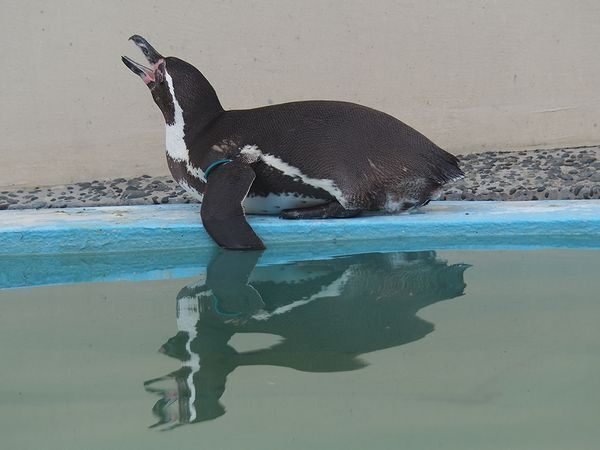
[200,160,265,250]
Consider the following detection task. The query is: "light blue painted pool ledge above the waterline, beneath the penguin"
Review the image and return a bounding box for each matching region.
[0,200,600,256]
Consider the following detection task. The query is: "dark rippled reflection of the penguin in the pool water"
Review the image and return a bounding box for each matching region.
[144,251,469,428]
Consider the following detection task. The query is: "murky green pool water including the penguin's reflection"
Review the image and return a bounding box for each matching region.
[0,250,600,450]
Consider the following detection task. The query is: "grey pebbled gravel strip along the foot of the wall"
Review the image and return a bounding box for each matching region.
[0,147,600,210]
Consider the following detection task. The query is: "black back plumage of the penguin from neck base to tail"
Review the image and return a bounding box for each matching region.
[192,101,463,209]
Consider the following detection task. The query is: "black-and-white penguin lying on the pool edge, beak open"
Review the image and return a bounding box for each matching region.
[122,35,464,250]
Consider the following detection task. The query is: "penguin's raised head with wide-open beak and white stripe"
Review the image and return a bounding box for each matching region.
[121,34,222,125]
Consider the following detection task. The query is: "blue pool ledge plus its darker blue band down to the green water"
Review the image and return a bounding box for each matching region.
[0,200,600,289]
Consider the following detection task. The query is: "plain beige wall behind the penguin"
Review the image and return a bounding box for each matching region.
[0,0,600,185]
